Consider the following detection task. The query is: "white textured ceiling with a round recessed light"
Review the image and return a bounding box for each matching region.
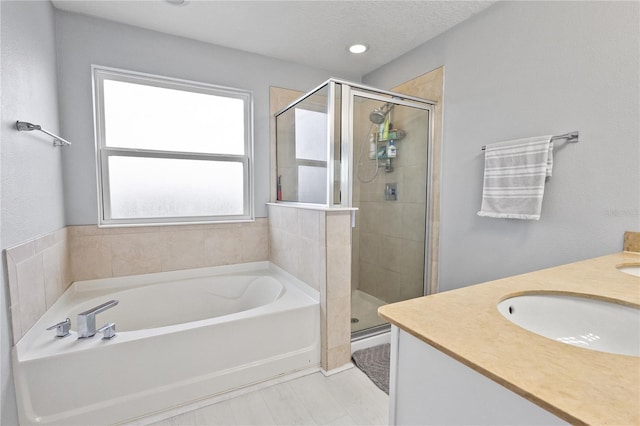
[52,0,494,76]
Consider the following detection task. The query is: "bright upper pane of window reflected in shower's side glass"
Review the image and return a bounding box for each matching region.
[295,108,327,161]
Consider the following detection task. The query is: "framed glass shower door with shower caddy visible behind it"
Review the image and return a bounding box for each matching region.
[351,91,430,338]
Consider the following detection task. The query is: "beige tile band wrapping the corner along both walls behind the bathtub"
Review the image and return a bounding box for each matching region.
[6,218,269,344]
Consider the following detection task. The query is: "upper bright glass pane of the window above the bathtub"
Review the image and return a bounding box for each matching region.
[103,80,245,155]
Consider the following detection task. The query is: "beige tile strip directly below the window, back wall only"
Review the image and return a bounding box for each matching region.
[69,218,269,281]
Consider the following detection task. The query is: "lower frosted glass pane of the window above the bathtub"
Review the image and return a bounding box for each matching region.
[109,157,244,219]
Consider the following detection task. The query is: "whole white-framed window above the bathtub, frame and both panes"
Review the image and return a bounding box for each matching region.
[93,66,253,225]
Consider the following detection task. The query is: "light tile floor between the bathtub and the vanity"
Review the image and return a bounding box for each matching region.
[148,368,389,426]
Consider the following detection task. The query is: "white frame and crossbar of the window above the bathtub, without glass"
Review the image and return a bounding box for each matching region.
[91,65,255,227]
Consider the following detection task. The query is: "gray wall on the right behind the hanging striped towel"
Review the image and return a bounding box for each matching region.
[363,2,640,290]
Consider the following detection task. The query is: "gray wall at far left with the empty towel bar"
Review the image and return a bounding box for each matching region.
[0,1,65,425]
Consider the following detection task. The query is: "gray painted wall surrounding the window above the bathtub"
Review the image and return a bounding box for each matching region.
[56,11,344,225]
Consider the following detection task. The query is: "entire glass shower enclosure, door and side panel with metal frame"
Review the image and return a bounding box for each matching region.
[275,79,434,339]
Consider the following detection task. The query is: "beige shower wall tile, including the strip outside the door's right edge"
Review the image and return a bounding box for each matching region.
[352,67,444,302]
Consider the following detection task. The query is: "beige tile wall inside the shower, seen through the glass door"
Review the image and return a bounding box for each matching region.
[352,102,428,303]
